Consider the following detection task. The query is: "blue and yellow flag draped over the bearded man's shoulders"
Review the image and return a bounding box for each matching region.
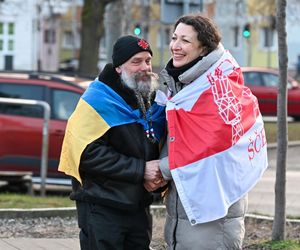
[58,80,165,183]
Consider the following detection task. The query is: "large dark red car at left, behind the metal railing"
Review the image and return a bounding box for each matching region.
[0,73,84,184]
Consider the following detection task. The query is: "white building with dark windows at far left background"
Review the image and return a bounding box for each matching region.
[0,0,38,70]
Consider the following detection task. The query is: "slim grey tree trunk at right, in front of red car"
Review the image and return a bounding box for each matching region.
[272,0,288,240]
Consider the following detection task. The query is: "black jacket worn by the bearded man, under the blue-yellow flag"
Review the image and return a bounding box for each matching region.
[70,64,163,212]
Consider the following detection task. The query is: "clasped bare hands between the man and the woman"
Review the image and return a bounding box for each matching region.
[144,160,167,192]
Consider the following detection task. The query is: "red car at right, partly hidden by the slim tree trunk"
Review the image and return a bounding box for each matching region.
[242,67,300,120]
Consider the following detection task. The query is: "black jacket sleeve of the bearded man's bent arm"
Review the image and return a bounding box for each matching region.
[80,138,146,183]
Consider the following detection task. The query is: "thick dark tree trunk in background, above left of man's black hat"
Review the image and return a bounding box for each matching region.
[78,0,114,77]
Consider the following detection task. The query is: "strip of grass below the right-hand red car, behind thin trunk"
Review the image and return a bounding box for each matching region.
[265,122,300,143]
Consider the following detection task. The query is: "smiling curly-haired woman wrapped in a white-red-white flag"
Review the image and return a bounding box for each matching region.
[160,14,267,249]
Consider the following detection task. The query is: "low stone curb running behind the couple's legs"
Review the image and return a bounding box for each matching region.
[0,205,300,225]
